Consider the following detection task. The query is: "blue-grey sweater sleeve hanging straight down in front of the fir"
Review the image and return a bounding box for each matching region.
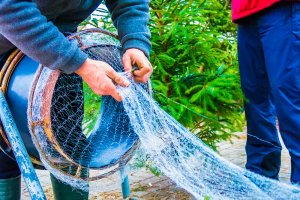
[106,0,151,57]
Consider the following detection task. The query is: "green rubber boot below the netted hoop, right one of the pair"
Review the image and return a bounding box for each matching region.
[50,174,89,200]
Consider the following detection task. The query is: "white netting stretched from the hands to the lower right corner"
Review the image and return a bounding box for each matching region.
[118,82,300,200]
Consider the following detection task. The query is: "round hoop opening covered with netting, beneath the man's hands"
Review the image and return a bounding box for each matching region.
[28,29,150,181]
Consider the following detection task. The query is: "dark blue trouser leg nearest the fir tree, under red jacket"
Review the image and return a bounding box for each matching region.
[238,15,281,178]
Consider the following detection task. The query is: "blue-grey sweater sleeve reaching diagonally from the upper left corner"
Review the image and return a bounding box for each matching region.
[0,0,87,73]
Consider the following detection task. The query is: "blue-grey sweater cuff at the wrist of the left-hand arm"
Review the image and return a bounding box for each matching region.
[60,49,88,74]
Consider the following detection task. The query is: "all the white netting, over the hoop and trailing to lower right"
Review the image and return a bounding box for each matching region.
[28,28,300,200]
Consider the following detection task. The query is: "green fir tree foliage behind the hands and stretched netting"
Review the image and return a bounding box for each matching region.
[83,0,244,149]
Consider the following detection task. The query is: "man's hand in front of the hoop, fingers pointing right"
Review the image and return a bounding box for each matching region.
[75,58,130,101]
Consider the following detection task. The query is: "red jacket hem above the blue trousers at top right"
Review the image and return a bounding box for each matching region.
[231,0,280,21]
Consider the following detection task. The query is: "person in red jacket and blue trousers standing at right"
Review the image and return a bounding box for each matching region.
[232,0,300,184]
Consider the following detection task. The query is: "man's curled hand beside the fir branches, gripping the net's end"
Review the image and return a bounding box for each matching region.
[122,49,152,83]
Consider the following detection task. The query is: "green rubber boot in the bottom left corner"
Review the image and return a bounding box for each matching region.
[0,176,21,200]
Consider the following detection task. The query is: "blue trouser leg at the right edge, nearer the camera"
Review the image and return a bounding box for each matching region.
[240,2,300,183]
